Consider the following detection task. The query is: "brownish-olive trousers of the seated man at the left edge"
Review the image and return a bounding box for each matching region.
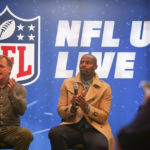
[0,127,33,150]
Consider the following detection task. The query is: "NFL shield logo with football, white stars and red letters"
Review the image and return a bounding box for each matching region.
[0,7,40,85]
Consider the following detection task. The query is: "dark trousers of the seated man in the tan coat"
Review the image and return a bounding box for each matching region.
[48,125,108,150]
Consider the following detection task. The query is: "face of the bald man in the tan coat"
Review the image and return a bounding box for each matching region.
[79,55,97,76]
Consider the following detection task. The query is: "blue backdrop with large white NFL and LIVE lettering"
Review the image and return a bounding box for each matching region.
[0,0,150,150]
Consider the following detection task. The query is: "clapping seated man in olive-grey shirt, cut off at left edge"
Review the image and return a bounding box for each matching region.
[0,55,33,150]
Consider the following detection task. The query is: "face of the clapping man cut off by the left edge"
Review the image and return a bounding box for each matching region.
[0,58,11,80]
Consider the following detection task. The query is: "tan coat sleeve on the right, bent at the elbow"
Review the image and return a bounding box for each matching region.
[88,85,111,124]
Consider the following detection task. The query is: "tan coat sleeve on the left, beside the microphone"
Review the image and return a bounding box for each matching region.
[57,81,75,120]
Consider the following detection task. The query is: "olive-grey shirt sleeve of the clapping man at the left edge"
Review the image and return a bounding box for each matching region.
[9,84,27,115]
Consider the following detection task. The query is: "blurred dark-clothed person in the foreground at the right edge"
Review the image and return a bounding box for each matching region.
[117,83,150,150]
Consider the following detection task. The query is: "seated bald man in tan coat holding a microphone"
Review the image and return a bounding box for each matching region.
[49,54,114,150]
